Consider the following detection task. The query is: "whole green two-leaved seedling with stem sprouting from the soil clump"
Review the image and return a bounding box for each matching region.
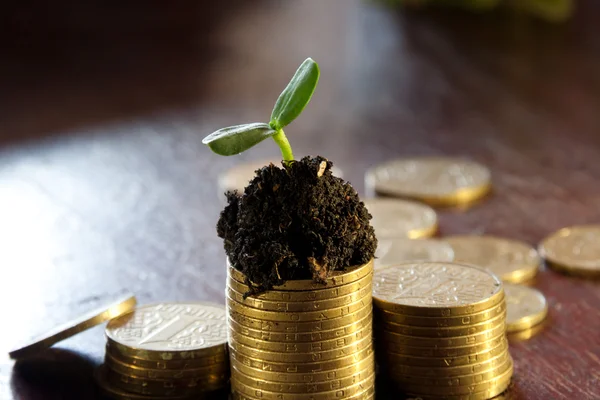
[202,58,319,162]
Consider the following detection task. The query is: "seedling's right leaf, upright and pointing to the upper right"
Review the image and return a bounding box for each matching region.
[269,58,319,130]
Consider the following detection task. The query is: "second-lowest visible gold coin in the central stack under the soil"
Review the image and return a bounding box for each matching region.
[231,353,375,383]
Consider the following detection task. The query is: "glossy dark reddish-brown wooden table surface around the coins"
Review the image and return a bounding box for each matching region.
[0,0,600,400]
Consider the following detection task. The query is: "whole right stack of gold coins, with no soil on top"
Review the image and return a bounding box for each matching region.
[373,262,513,400]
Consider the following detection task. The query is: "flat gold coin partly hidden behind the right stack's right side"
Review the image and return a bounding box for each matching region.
[504,285,548,332]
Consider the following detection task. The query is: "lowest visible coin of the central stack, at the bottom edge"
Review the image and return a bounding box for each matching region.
[231,374,375,400]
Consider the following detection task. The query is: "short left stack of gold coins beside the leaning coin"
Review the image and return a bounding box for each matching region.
[96,303,229,400]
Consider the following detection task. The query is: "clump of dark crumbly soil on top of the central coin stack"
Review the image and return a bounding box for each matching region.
[217,157,377,293]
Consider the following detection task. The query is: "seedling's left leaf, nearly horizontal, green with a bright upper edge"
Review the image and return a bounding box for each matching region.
[202,122,277,156]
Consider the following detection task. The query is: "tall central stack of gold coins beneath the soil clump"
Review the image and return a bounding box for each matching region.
[227,261,375,400]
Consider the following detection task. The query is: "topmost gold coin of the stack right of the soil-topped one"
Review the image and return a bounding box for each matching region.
[373,262,504,317]
